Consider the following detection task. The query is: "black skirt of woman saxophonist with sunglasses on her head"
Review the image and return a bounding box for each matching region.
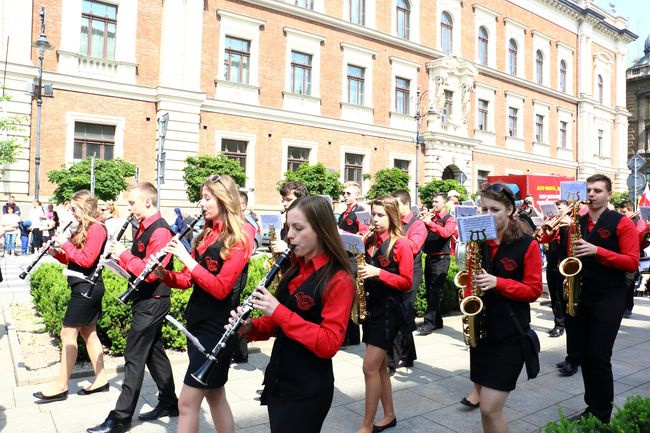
[469,340,524,392]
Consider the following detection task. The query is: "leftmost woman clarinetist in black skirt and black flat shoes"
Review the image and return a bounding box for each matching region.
[34,190,108,403]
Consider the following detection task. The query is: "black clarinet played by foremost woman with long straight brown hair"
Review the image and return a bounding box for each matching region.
[192,245,293,385]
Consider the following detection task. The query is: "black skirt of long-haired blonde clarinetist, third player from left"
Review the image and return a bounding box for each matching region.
[183,321,235,389]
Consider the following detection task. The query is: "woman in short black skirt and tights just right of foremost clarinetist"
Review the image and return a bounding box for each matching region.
[357,196,413,433]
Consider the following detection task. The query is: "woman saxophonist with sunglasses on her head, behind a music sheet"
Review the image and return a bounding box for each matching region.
[470,183,542,433]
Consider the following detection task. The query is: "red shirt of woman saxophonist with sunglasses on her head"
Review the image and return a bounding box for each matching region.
[487,240,542,302]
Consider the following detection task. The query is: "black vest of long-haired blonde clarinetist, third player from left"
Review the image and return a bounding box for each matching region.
[185,239,248,326]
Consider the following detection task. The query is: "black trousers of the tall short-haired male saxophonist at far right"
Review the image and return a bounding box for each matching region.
[576,286,625,422]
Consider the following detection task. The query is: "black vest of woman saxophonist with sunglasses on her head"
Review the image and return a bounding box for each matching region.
[481,235,533,342]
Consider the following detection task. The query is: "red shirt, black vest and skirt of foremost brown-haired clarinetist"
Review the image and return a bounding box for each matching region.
[246,253,354,433]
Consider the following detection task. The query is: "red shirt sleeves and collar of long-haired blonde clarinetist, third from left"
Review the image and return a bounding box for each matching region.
[163,221,251,301]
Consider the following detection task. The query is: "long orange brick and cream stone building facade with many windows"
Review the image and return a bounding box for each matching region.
[0,0,636,213]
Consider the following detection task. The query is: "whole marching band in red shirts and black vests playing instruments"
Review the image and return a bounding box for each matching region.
[21,175,650,433]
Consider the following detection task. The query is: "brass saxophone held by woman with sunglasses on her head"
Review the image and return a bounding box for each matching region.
[454,232,487,348]
